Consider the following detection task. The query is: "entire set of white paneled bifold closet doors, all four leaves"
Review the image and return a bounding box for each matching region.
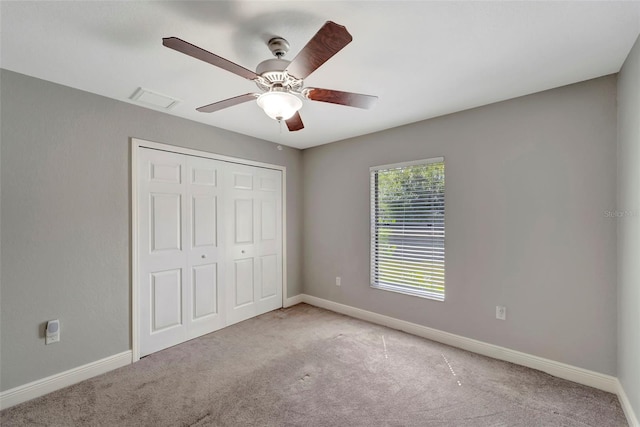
[137,148,282,356]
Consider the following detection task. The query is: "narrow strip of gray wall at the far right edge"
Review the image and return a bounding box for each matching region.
[617,38,640,416]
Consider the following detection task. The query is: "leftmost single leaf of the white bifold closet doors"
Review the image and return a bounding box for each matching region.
[137,149,189,356]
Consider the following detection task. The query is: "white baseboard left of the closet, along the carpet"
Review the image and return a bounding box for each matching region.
[0,350,132,410]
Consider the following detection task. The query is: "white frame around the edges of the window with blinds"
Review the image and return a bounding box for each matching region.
[369,156,446,302]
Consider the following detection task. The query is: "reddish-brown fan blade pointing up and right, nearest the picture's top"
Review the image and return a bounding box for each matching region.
[286,21,353,79]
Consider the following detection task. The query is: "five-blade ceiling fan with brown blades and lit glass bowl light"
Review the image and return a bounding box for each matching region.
[162,21,378,131]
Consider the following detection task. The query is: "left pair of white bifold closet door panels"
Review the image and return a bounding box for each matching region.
[138,149,226,356]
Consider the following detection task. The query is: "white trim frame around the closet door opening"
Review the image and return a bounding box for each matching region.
[129,138,287,362]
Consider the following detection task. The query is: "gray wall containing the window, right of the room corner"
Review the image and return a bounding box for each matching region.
[303,76,617,375]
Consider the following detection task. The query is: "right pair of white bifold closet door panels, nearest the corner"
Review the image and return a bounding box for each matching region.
[225,163,282,324]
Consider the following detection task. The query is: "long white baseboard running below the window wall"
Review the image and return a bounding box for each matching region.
[302,294,619,393]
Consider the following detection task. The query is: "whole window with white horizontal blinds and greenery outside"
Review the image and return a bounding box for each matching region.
[370,157,444,301]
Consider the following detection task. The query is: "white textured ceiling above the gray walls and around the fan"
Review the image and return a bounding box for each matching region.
[0,1,640,148]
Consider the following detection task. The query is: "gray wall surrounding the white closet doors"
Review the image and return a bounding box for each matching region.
[0,70,302,390]
